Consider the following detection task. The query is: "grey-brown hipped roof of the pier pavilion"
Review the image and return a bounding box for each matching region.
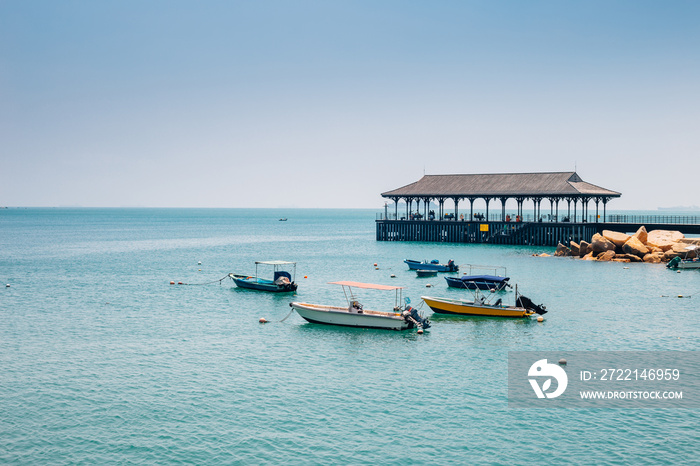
[382,172,621,198]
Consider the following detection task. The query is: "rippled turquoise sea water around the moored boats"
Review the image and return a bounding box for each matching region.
[0,209,700,464]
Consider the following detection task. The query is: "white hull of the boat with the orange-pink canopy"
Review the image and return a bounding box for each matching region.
[290,302,409,330]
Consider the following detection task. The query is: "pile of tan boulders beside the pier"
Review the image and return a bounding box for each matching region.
[554,226,700,263]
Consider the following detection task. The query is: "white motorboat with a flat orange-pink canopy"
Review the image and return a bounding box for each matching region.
[289,281,430,333]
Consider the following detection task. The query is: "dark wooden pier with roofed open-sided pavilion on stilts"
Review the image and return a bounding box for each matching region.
[376,172,700,246]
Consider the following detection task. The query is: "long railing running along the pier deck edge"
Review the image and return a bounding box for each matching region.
[376,212,700,225]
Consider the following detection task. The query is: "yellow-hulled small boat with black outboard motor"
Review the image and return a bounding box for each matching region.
[421,290,547,317]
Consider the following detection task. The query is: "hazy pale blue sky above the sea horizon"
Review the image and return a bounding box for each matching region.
[0,0,700,210]
